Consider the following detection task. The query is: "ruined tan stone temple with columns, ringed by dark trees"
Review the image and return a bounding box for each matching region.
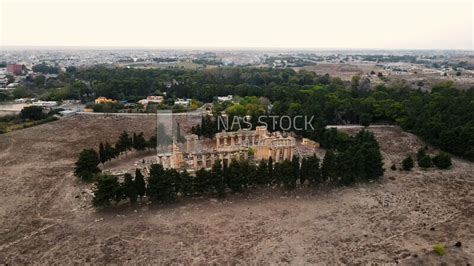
[157,126,295,170]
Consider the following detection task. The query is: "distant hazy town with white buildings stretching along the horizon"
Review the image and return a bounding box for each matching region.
[0,48,474,118]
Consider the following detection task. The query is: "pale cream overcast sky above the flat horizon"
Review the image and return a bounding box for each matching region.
[0,0,474,50]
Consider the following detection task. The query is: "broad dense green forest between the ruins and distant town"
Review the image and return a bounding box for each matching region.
[70,67,474,161]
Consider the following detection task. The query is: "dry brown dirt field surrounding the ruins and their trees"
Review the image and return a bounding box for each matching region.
[0,115,474,265]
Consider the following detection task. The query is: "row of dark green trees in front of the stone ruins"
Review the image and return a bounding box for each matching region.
[93,131,384,207]
